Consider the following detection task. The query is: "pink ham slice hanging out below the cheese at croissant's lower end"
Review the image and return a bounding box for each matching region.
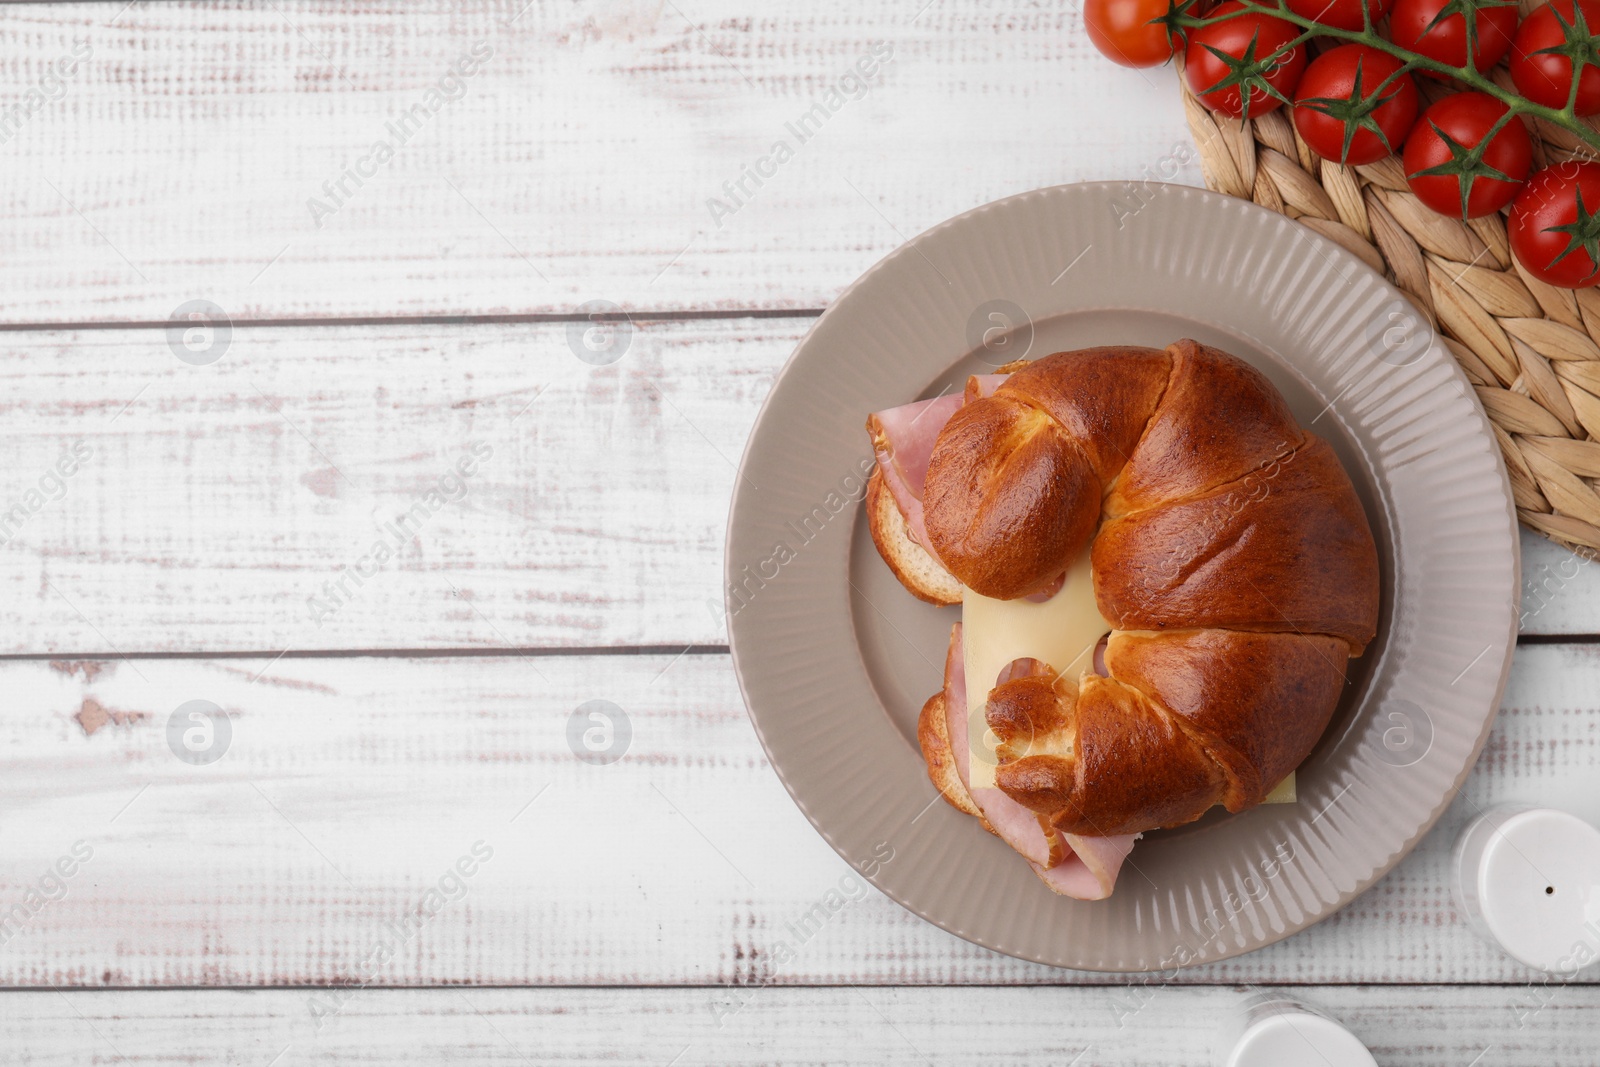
[944,625,1138,901]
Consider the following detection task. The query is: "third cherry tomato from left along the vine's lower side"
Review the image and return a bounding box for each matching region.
[1294,45,1418,166]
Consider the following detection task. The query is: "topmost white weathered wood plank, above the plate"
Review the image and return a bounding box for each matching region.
[0,0,1200,323]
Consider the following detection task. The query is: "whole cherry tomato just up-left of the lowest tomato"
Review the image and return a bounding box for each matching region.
[1403,93,1536,219]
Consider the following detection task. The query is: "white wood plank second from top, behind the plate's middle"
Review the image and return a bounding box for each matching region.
[0,318,1600,656]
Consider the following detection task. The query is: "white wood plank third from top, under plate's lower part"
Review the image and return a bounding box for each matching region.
[0,645,1600,985]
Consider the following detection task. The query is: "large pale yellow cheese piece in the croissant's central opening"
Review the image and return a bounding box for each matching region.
[962,552,1112,789]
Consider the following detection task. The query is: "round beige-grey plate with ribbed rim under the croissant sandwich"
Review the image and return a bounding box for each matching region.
[728,182,1518,971]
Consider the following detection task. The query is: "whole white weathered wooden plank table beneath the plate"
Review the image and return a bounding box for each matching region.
[0,0,1600,1067]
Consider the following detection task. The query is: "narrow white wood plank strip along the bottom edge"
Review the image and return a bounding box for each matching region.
[0,985,1600,1067]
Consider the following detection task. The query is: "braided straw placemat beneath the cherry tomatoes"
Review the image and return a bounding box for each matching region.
[1178,60,1600,558]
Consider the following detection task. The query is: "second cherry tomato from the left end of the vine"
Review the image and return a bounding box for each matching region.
[1184,0,1306,118]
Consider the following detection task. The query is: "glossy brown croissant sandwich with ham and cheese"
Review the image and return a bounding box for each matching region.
[866,341,1378,899]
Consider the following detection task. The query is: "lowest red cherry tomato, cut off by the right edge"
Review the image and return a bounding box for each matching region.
[1506,163,1600,290]
